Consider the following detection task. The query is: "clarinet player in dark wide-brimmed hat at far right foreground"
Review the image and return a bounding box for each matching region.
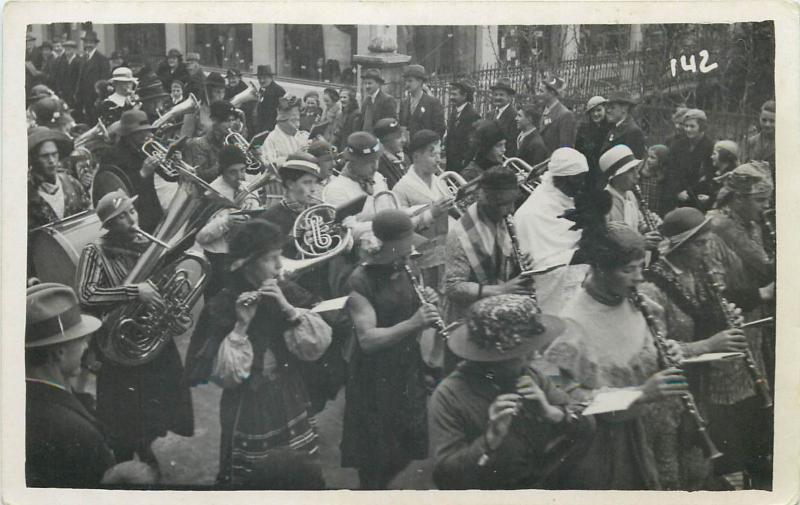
[638,207,775,488]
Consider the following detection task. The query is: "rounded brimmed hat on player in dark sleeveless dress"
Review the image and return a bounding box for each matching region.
[364,209,428,265]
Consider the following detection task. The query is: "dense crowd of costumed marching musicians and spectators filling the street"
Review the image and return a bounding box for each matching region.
[25,36,775,490]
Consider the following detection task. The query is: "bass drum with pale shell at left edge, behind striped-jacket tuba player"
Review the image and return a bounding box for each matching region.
[28,211,101,288]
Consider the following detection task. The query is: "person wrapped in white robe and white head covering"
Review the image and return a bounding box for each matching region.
[514,147,589,272]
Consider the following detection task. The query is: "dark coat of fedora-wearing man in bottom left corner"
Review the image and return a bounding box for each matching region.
[23,381,114,488]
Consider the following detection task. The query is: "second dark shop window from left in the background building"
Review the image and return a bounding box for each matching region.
[186,24,253,72]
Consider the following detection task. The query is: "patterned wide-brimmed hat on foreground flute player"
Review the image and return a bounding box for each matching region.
[447,295,565,362]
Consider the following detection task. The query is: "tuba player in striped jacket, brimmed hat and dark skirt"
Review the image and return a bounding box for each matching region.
[76,190,194,469]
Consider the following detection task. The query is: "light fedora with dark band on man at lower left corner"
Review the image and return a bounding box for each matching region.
[25,282,102,349]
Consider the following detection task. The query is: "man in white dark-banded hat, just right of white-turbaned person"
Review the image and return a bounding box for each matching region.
[600,145,661,250]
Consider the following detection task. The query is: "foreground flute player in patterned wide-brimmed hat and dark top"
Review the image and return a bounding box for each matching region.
[431,295,594,489]
